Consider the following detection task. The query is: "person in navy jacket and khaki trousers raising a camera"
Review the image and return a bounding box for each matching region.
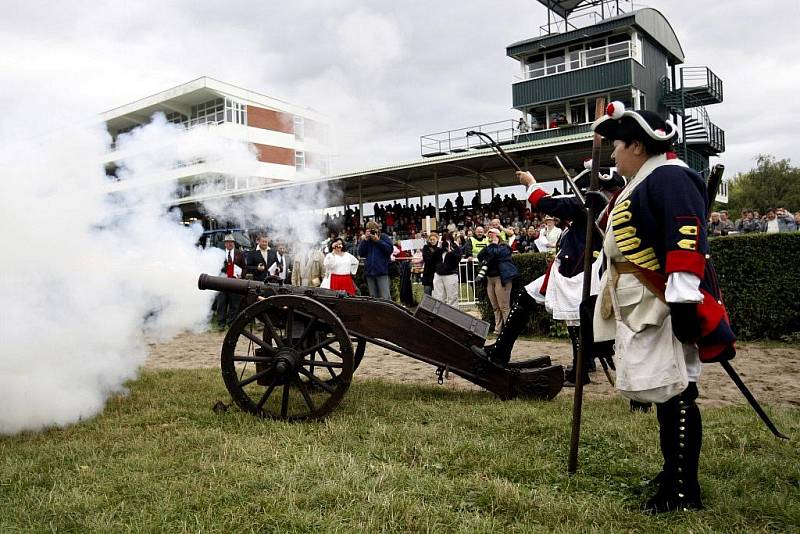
[475,228,519,334]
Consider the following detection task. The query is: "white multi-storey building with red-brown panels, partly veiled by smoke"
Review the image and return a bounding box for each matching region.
[101,77,331,218]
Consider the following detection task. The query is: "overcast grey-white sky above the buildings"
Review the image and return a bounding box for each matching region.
[0,0,800,176]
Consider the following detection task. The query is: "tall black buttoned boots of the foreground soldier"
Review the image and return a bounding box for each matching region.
[644,382,703,513]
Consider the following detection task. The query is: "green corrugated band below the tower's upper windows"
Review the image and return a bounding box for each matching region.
[511,59,634,109]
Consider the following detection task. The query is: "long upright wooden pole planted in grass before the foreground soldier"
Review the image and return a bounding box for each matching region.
[567,98,606,474]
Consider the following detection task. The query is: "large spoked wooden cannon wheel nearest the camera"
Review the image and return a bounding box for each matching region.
[221,295,354,421]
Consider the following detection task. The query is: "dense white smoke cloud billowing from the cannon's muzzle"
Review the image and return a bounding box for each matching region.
[0,112,278,434]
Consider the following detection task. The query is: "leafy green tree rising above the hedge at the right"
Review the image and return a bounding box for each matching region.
[726,154,800,219]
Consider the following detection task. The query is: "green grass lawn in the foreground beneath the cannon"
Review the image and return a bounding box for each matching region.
[0,370,800,533]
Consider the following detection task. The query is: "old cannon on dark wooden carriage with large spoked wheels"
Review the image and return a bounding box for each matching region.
[198,274,564,421]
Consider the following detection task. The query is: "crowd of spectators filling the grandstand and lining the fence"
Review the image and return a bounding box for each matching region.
[216,195,800,324]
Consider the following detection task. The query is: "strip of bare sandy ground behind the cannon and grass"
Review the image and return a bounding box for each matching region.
[146,332,800,406]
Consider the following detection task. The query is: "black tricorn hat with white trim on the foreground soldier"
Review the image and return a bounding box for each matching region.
[592,102,678,141]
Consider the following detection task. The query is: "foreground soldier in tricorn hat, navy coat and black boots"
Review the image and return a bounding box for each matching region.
[592,102,735,513]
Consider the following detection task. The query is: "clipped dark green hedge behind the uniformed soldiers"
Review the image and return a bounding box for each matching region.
[478,232,800,340]
